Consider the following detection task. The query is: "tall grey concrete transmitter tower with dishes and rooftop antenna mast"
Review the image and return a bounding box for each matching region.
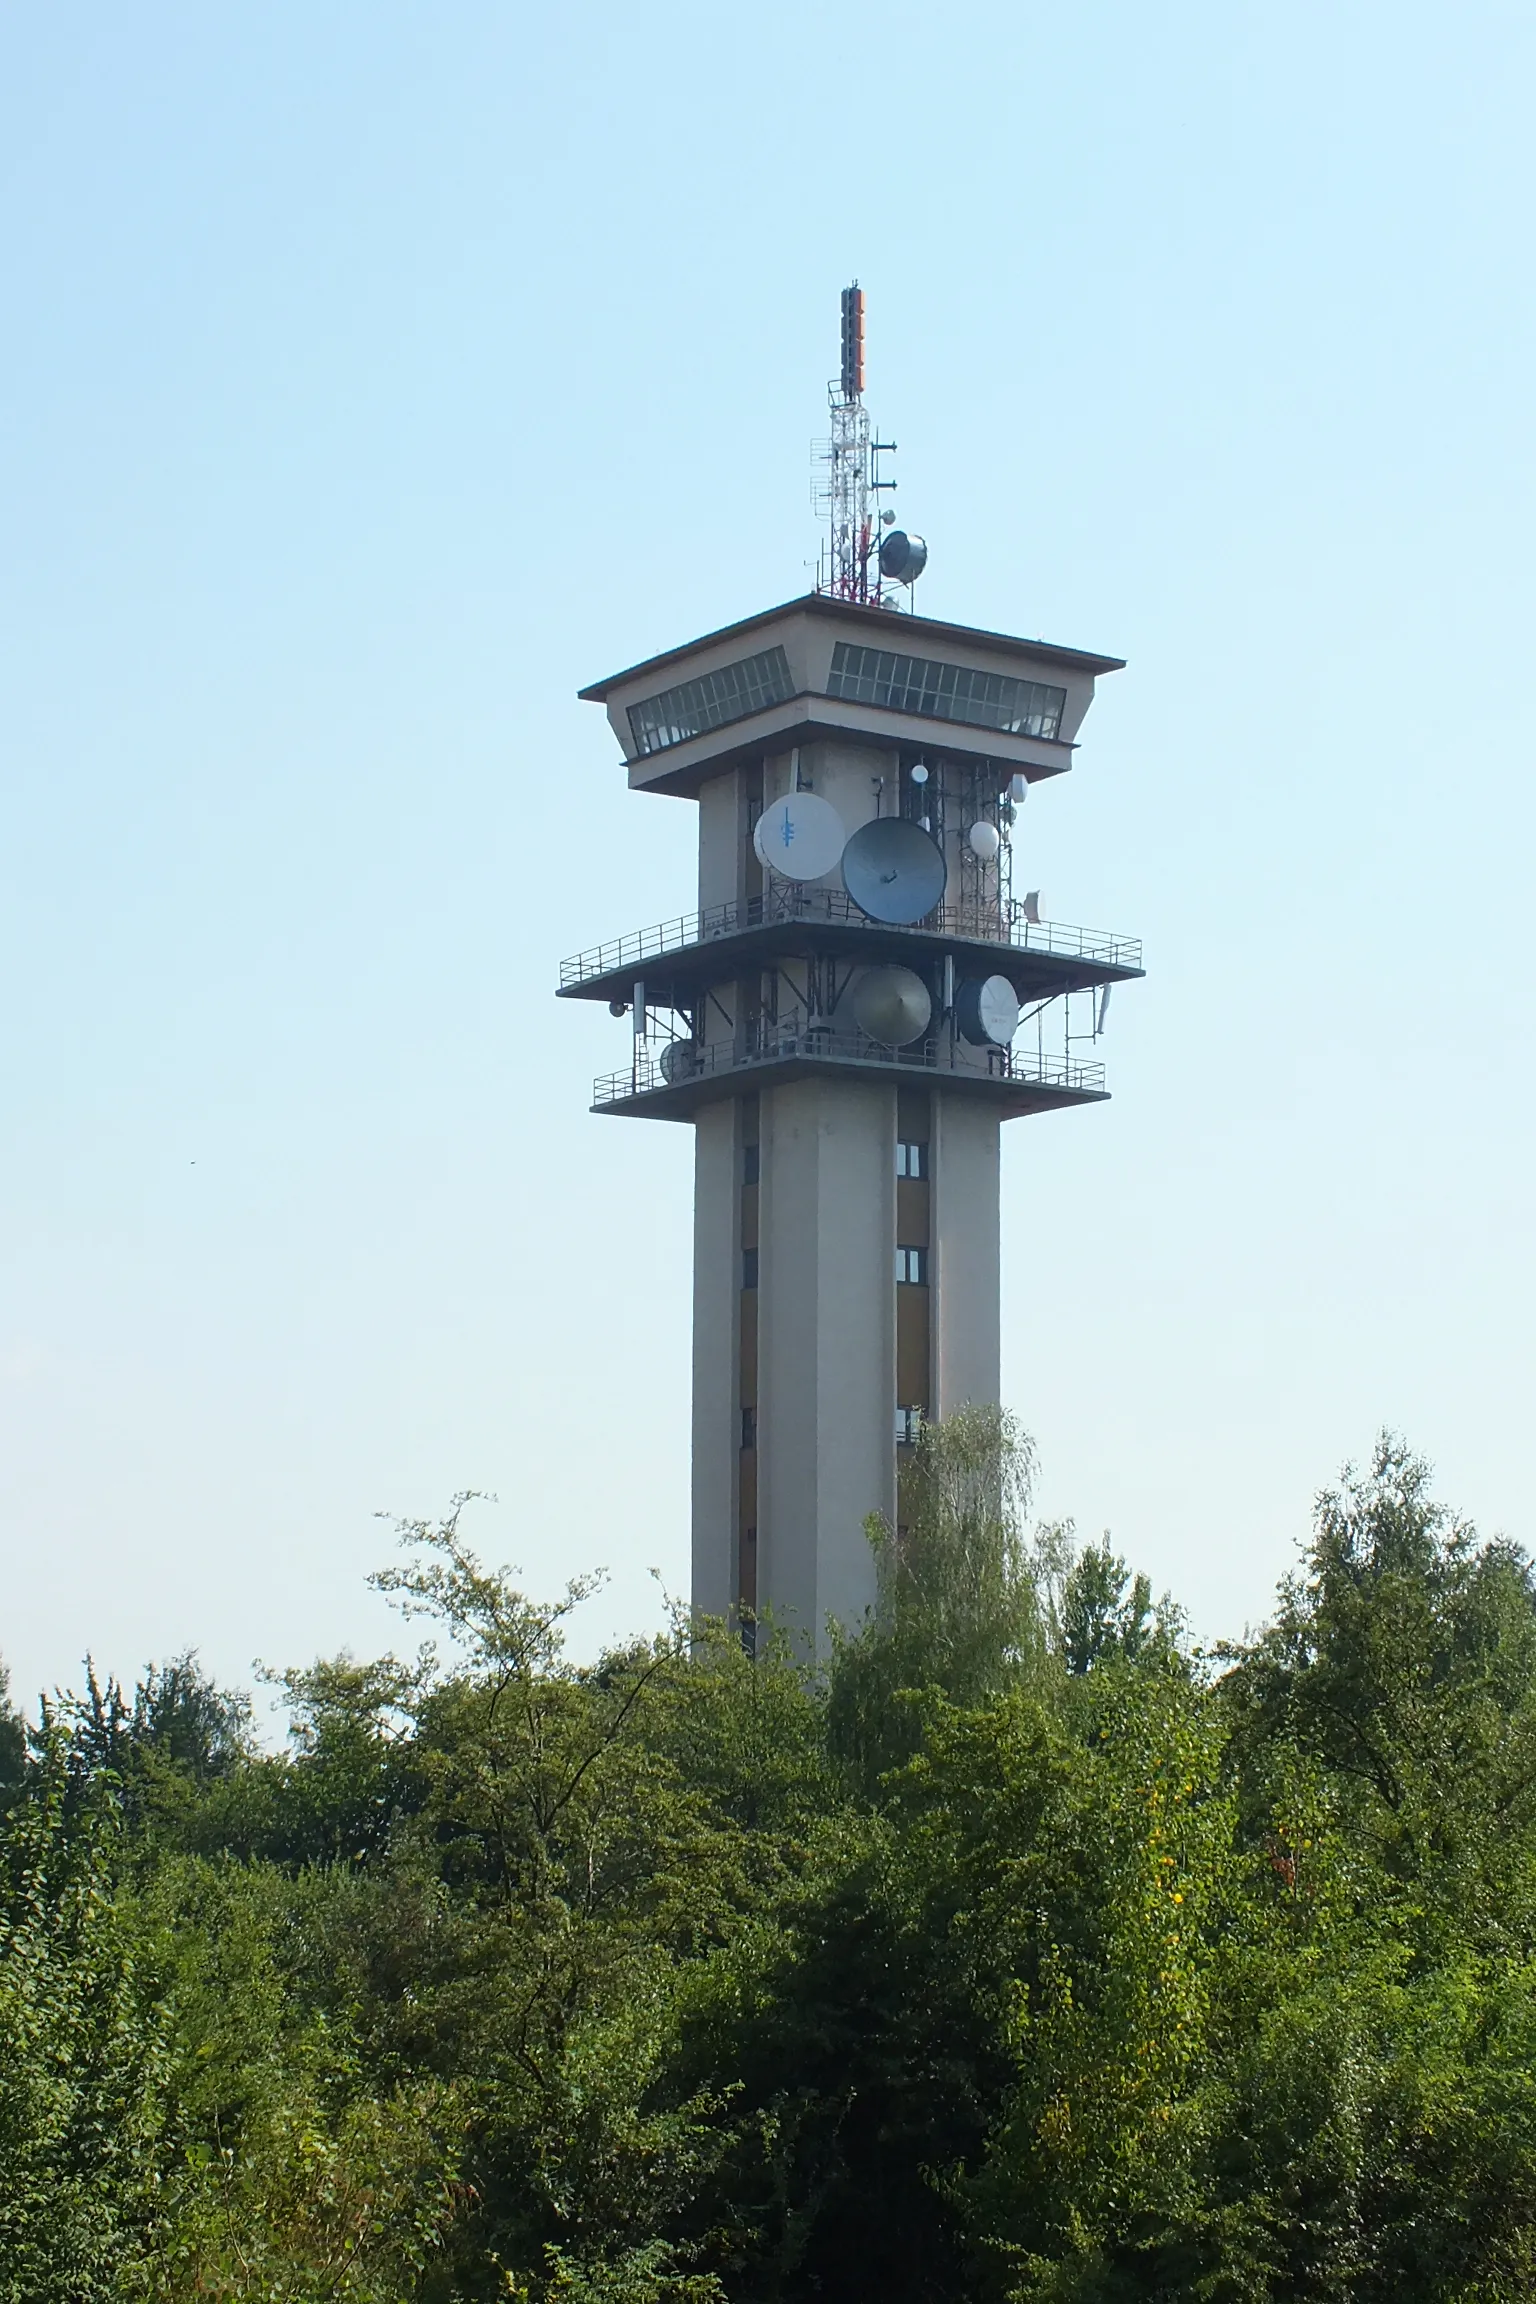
[560,286,1142,1643]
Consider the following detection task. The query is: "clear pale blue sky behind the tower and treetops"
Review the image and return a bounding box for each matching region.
[0,0,1536,1696]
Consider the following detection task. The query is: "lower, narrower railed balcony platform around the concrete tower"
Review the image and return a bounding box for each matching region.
[592,1028,1108,1120]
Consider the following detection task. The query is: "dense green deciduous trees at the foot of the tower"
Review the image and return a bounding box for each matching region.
[0,1415,1536,2304]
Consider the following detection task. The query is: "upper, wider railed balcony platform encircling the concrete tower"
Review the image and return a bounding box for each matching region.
[560,880,1142,1007]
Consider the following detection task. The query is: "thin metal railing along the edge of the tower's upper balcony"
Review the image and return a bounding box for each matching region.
[560,882,1142,991]
